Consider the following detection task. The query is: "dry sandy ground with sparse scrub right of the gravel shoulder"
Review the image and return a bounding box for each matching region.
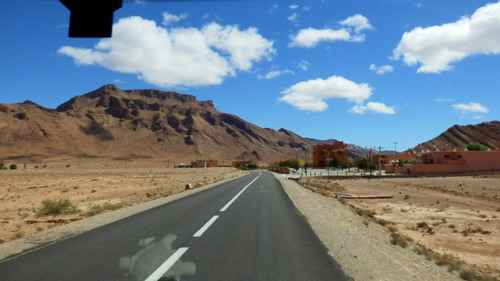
[304,175,500,278]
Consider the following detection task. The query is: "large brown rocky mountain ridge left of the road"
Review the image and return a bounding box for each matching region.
[0,85,314,164]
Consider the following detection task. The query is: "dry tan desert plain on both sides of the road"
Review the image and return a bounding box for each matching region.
[0,166,500,278]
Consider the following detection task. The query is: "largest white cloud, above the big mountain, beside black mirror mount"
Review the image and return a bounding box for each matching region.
[58,17,275,87]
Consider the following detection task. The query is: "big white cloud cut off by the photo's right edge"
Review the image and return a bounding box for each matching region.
[393,2,500,73]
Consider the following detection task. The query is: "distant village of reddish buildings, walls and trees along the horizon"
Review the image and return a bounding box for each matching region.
[186,141,500,175]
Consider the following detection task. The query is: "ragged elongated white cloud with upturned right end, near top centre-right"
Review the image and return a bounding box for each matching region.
[288,15,373,48]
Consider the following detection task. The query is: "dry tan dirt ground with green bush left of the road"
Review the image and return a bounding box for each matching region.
[0,168,240,243]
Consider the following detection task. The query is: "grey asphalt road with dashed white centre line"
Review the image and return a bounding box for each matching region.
[0,172,347,281]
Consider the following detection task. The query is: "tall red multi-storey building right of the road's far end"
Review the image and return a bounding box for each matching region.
[313,141,349,168]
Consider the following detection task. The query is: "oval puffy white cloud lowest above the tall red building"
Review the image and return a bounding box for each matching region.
[279,76,372,111]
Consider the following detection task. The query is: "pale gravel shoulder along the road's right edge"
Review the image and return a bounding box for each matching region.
[275,175,461,281]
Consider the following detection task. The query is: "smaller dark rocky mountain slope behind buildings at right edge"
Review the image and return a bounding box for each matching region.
[414,121,500,151]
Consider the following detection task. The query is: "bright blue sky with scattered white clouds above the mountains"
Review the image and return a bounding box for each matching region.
[0,0,500,150]
